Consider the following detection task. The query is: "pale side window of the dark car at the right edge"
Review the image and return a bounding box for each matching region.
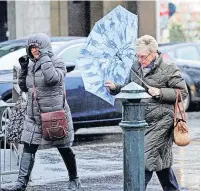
[176,46,200,61]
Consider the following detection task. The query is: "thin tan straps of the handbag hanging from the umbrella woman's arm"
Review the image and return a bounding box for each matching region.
[174,89,186,123]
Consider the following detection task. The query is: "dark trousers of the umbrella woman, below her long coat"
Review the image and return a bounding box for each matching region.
[145,168,179,191]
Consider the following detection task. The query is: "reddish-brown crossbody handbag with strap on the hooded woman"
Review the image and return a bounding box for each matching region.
[33,84,68,141]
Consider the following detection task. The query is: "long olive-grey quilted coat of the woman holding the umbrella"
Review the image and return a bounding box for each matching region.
[111,55,188,171]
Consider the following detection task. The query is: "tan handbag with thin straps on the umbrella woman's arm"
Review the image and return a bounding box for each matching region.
[174,89,190,146]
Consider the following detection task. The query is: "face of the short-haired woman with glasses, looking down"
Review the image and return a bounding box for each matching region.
[136,52,157,67]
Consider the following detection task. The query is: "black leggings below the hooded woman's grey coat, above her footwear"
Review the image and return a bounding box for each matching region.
[23,143,78,180]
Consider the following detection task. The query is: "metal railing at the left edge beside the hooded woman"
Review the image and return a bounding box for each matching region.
[0,71,23,187]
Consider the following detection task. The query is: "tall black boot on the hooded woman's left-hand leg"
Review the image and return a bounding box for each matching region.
[1,153,35,191]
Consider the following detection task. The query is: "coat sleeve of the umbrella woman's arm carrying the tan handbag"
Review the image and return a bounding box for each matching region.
[160,64,188,103]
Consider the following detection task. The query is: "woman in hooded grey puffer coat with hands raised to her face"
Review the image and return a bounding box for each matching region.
[2,33,81,191]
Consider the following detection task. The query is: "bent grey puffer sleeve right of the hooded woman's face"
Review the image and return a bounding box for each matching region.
[40,56,66,86]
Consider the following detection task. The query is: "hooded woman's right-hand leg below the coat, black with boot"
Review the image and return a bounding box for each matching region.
[58,148,81,191]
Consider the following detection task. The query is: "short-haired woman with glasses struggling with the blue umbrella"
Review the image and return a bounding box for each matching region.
[105,35,188,191]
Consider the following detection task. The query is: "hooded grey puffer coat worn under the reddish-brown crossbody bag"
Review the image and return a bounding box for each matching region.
[18,33,74,148]
